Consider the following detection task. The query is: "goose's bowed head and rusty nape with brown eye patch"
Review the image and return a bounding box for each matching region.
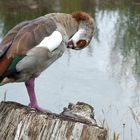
[67,12,95,50]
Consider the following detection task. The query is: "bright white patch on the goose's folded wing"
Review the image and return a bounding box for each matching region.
[37,31,63,51]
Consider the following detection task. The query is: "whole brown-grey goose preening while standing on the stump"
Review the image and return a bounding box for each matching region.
[0,11,95,111]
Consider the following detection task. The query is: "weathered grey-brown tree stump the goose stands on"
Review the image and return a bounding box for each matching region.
[0,102,107,140]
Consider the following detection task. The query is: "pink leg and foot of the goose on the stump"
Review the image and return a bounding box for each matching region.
[25,78,48,112]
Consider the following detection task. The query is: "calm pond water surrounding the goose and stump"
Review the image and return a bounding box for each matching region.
[0,0,140,140]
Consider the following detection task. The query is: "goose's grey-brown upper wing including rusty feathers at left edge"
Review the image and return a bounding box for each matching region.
[0,17,56,76]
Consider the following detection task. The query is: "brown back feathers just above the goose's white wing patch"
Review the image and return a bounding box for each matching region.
[7,17,56,58]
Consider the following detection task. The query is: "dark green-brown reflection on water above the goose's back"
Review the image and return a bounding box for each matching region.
[0,0,95,34]
